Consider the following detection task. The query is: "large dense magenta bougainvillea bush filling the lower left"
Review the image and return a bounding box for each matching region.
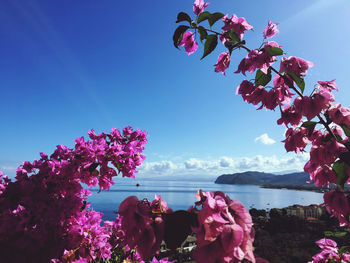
[0,127,147,262]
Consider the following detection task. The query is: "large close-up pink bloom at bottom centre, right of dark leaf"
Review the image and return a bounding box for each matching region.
[193,190,255,263]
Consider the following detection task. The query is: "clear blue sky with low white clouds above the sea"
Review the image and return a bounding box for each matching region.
[0,0,350,177]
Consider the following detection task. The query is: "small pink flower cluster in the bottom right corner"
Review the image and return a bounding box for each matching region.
[309,238,350,263]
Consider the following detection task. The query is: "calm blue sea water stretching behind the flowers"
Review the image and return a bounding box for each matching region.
[88,178,323,220]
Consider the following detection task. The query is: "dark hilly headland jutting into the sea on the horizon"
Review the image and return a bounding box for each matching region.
[215,171,322,192]
